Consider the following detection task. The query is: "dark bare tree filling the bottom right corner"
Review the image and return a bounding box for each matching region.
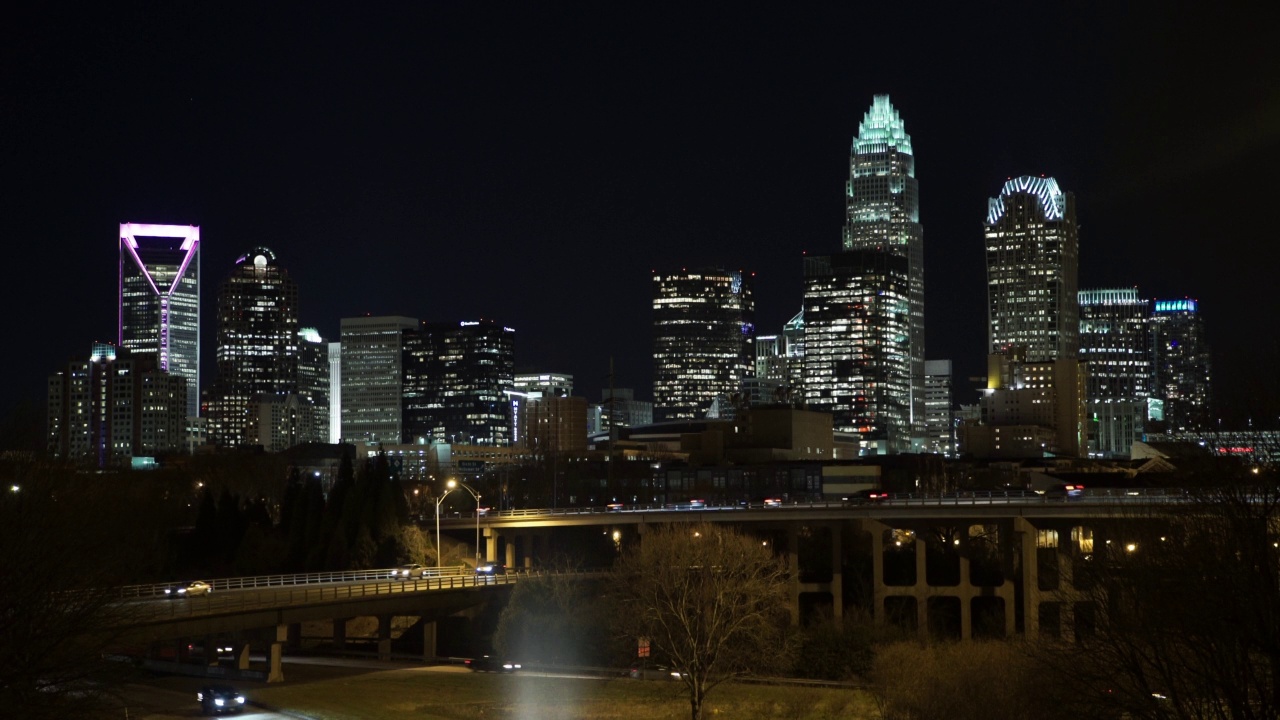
[1039,478,1280,720]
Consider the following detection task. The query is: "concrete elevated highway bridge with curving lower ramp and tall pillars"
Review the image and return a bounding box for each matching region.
[110,488,1188,680]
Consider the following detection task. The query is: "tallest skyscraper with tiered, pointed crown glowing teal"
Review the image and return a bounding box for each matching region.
[844,95,924,438]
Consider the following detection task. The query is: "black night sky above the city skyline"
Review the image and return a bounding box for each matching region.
[0,1,1280,427]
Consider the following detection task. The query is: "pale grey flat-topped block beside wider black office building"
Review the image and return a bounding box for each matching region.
[339,315,417,445]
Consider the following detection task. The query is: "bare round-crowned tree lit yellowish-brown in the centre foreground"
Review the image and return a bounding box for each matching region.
[614,524,788,720]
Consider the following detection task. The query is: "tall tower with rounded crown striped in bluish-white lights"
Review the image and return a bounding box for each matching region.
[986,176,1080,363]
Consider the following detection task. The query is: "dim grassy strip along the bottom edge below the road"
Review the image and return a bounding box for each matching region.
[253,669,877,720]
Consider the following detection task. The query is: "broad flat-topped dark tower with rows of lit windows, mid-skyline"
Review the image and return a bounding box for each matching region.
[653,269,755,420]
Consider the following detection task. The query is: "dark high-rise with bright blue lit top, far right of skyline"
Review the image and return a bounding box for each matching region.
[1151,299,1213,433]
